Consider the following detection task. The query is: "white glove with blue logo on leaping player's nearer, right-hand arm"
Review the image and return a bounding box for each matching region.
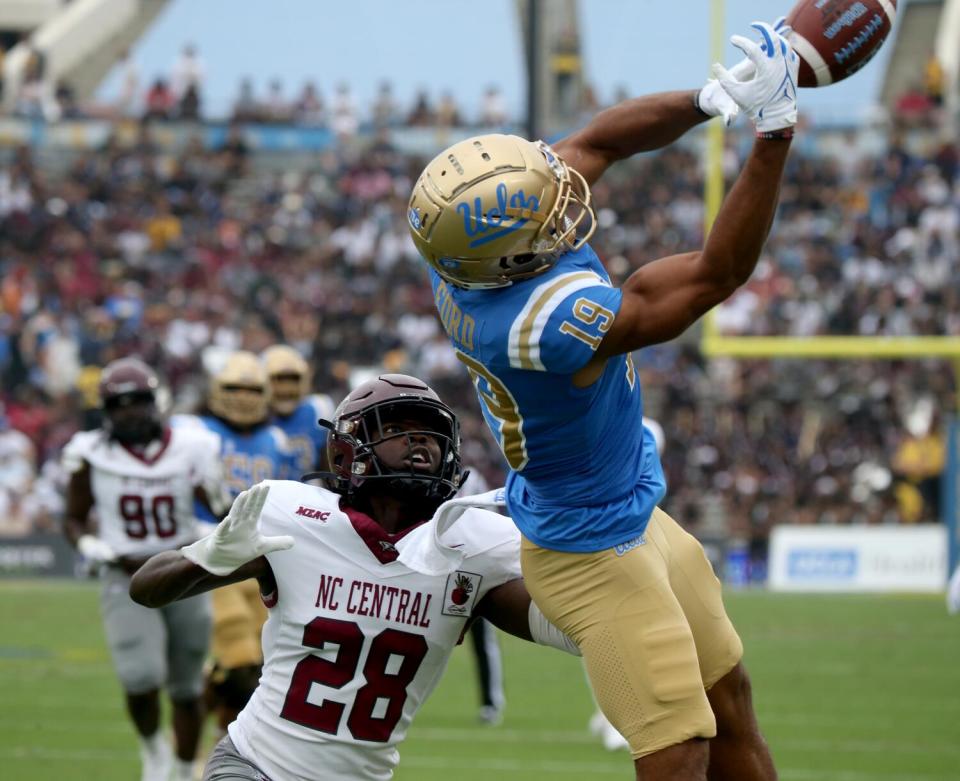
[713,22,800,133]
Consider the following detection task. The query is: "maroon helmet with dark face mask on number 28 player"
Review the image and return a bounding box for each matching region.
[320,374,465,504]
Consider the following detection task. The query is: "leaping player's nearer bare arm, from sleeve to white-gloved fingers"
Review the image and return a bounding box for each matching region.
[595,24,799,360]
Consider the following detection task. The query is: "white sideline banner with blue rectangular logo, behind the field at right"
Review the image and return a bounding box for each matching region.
[769,524,947,592]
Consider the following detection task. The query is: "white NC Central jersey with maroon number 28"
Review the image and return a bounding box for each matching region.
[229,481,520,781]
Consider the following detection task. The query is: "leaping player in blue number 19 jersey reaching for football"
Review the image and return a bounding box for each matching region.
[408,23,799,781]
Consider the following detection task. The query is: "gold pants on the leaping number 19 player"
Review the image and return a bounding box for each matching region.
[521,508,743,758]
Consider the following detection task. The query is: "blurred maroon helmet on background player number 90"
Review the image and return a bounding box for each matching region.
[100,358,163,445]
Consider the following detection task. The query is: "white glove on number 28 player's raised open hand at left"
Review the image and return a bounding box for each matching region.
[180,485,293,575]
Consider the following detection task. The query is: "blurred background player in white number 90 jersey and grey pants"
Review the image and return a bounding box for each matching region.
[62,358,229,781]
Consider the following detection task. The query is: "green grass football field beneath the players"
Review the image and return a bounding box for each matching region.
[0,581,960,781]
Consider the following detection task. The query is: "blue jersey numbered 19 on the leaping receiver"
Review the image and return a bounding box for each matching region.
[432,241,666,552]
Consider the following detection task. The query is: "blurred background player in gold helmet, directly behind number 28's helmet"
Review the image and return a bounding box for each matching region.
[261,344,334,477]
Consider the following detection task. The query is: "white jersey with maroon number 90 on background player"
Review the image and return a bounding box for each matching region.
[61,426,222,556]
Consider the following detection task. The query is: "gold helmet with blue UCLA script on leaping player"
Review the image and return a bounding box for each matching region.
[407,134,596,289]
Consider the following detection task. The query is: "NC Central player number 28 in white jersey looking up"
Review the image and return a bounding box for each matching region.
[131,374,576,781]
